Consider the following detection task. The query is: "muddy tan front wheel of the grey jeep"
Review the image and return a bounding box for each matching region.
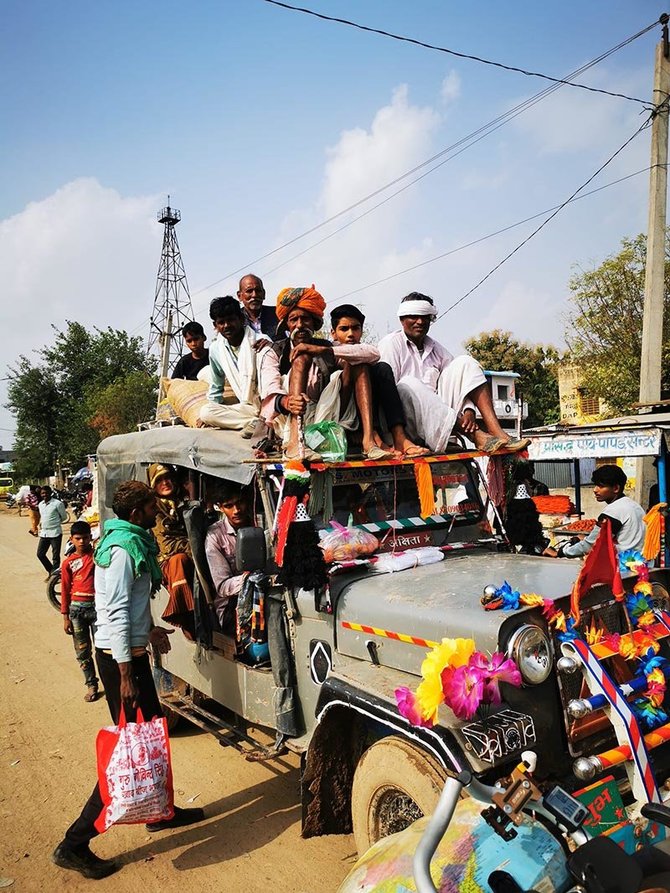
[351,735,447,856]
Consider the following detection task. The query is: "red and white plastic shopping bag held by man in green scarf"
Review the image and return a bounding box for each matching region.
[95,707,174,833]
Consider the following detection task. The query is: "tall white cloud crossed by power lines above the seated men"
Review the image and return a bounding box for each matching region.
[261,86,441,331]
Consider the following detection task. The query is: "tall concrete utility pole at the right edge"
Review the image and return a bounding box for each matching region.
[635,13,670,505]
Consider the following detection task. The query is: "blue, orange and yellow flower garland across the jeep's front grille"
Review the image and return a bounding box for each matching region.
[481,549,670,729]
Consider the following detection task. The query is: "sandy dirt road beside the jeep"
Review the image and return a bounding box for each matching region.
[0,504,355,893]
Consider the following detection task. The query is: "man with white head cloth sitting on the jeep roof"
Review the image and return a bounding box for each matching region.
[378,292,530,453]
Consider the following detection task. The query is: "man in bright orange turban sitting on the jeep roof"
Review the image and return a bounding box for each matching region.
[260,287,394,459]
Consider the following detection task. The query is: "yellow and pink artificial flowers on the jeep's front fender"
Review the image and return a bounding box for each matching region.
[395,639,521,728]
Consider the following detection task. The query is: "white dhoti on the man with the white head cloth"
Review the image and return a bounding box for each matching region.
[398,354,486,453]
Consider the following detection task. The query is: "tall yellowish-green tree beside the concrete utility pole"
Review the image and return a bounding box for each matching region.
[566,235,670,413]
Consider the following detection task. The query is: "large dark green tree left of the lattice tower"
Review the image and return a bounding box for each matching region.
[7,322,156,479]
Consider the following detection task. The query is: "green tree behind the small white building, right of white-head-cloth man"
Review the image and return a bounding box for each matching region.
[465,329,561,428]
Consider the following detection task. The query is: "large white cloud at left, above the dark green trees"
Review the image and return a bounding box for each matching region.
[0,178,161,440]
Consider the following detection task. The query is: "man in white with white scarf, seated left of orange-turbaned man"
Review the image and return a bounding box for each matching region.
[198,295,260,437]
